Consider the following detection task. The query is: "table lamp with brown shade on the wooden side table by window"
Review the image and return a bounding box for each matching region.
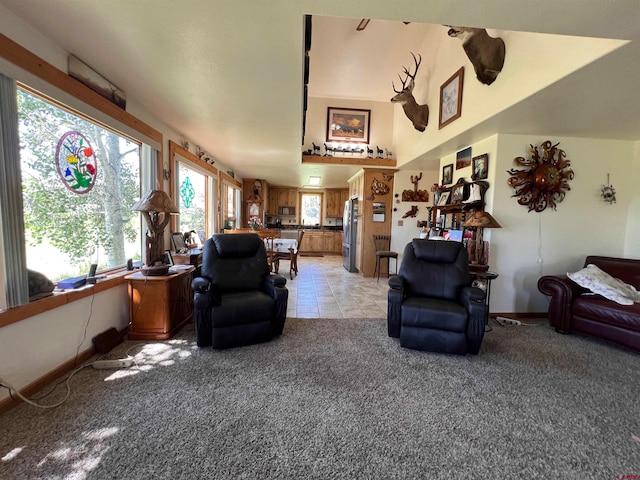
[133,190,179,276]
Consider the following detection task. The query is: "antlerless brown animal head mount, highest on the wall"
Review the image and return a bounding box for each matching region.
[447,25,506,85]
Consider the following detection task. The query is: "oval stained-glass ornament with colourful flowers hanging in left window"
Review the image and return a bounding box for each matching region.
[56,131,98,195]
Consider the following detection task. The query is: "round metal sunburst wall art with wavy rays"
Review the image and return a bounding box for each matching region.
[507,140,573,212]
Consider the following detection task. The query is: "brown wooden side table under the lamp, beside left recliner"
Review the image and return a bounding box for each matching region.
[125,266,195,340]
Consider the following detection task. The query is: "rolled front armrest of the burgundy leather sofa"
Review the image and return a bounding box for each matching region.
[538,275,587,333]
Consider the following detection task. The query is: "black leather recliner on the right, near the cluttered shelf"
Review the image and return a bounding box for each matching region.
[387,239,488,355]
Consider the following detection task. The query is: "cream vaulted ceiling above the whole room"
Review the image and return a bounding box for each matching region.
[0,0,640,186]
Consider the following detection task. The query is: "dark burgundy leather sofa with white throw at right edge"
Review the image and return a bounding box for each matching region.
[538,256,640,351]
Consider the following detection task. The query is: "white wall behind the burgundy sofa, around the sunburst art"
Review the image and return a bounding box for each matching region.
[490,135,640,312]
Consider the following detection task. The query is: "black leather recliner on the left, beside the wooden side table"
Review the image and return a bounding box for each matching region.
[192,233,289,348]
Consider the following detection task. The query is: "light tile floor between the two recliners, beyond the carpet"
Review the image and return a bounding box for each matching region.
[280,255,389,318]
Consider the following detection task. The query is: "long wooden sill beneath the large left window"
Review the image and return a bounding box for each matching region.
[0,270,131,328]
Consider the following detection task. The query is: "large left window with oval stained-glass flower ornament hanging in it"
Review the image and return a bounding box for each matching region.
[17,89,142,281]
